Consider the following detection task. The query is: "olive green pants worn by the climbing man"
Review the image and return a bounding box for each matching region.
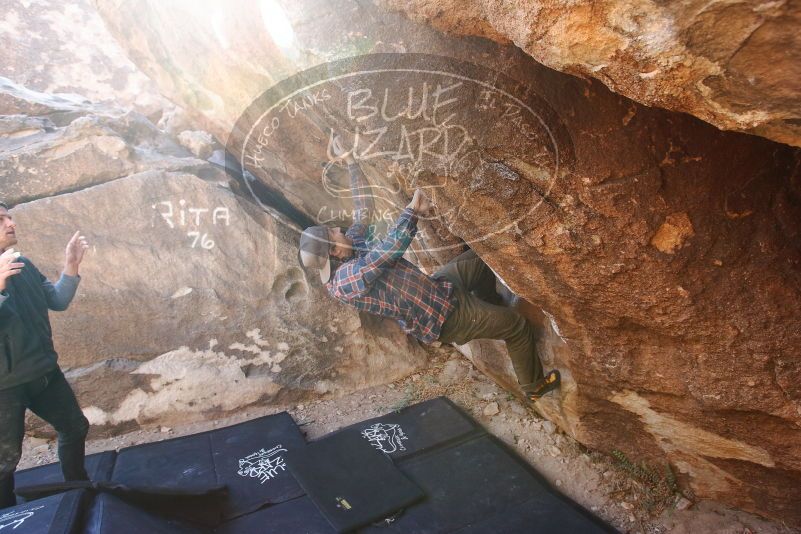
[434,250,543,384]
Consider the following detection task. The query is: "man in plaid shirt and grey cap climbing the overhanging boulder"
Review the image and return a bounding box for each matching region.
[300,137,560,400]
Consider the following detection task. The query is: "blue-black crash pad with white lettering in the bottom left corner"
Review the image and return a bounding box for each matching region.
[0,490,87,534]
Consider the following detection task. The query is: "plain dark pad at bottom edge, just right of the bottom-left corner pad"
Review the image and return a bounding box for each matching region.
[83,493,207,534]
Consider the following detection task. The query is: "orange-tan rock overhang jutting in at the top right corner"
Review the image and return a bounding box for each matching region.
[378,0,801,146]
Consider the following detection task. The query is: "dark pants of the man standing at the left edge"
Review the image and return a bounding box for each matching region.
[0,369,89,508]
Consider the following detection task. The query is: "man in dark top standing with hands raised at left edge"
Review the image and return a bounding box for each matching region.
[0,202,89,508]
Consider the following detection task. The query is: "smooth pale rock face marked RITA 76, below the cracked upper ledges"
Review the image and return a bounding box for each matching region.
[13,171,424,436]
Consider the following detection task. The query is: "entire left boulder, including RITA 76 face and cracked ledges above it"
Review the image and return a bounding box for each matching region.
[0,78,425,440]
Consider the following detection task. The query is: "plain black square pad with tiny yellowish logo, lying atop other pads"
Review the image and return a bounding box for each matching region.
[287,432,424,532]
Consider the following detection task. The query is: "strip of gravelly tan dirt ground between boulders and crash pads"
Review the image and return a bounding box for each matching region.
[20,347,801,534]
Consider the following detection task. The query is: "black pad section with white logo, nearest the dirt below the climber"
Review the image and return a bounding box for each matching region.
[324,397,484,460]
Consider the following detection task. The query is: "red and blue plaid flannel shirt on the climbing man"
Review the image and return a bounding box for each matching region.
[326,164,453,343]
